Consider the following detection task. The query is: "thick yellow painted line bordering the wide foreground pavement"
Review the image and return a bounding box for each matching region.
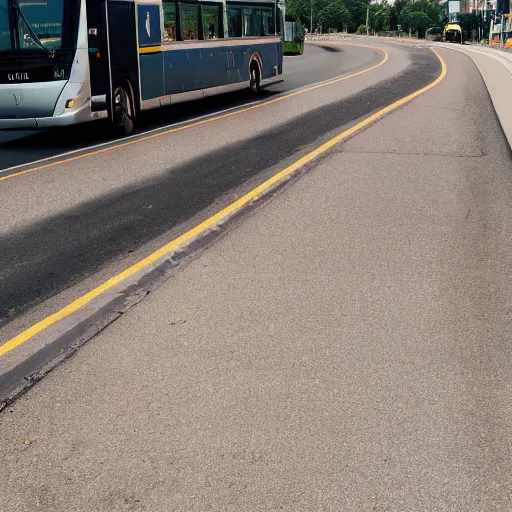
[0,48,447,357]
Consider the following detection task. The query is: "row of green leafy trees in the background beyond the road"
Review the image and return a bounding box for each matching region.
[286,0,442,37]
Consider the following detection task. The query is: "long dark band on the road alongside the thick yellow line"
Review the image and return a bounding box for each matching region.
[0,48,440,326]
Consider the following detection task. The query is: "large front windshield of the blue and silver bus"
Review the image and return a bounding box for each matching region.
[0,0,73,51]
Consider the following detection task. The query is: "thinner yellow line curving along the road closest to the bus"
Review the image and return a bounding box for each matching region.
[0,43,389,182]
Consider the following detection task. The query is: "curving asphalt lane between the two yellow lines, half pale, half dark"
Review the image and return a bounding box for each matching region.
[0,46,440,332]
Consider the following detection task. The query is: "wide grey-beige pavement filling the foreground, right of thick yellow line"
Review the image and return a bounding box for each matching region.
[0,50,512,512]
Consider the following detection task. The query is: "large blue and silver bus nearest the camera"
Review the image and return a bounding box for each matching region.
[0,0,283,135]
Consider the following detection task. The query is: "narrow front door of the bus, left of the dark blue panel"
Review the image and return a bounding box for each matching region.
[87,0,111,111]
